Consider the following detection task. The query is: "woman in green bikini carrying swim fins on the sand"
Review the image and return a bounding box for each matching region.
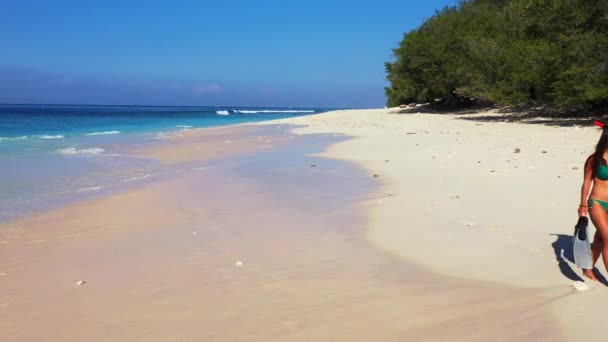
[578,123,608,280]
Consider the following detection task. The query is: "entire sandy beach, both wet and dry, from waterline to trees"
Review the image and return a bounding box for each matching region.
[0,110,606,341]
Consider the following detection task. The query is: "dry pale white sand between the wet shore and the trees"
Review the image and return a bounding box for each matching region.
[264,110,608,341]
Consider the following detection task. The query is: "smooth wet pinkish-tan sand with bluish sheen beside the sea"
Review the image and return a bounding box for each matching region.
[0,120,568,341]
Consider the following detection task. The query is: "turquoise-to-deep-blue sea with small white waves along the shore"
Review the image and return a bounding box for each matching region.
[0,104,326,222]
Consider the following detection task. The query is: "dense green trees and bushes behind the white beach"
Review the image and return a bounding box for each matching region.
[386,0,608,108]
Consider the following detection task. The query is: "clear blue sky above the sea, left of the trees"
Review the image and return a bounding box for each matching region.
[0,0,456,108]
